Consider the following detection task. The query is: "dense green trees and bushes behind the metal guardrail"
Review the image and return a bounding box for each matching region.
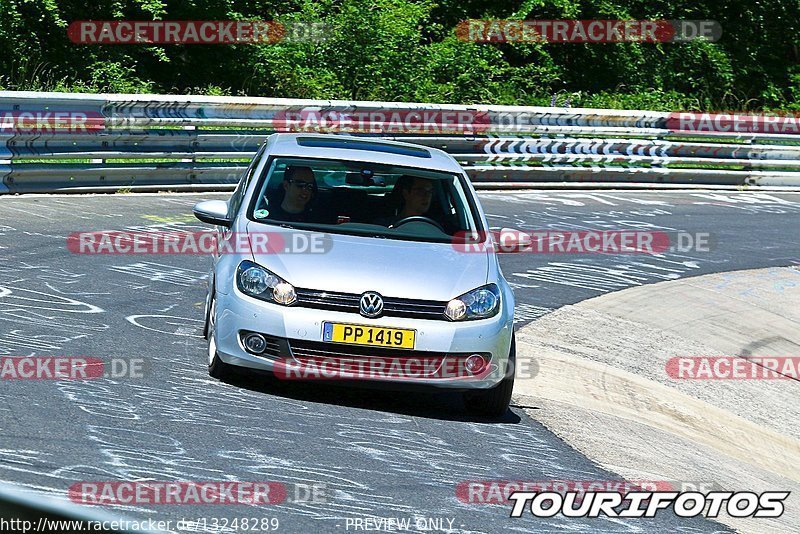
[0,0,800,110]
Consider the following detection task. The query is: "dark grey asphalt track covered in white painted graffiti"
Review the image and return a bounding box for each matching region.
[0,191,800,533]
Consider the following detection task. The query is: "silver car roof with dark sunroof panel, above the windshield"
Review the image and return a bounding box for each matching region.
[268,133,462,173]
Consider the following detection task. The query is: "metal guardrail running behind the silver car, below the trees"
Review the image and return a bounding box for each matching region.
[0,91,800,193]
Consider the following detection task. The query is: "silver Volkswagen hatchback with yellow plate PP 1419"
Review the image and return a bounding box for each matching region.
[194,134,515,416]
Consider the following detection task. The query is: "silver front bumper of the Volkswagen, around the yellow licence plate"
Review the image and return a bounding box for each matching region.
[216,288,513,390]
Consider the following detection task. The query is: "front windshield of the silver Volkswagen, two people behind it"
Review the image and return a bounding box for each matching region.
[248,157,481,242]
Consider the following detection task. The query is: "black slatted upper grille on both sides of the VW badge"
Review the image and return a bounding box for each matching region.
[295,289,447,321]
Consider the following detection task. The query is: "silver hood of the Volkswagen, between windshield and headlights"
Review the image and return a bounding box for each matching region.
[247,222,491,301]
